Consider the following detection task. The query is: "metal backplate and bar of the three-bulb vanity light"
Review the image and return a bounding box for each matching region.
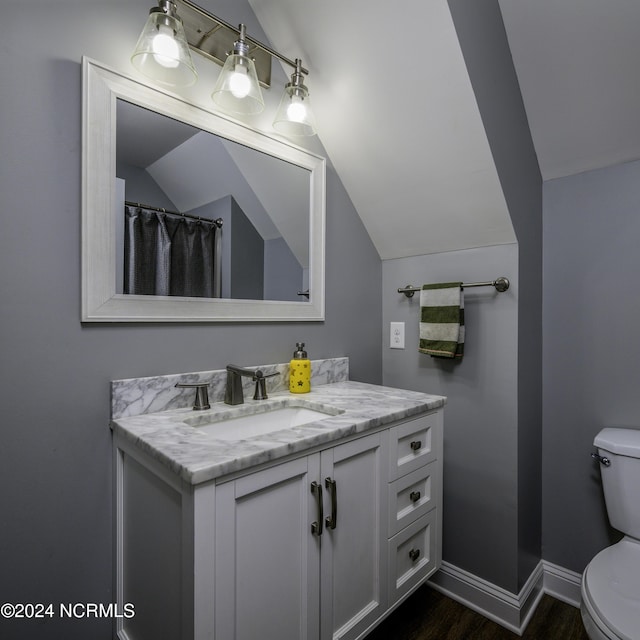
[174,0,309,87]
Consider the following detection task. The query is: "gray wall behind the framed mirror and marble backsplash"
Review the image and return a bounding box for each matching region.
[0,0,381,640]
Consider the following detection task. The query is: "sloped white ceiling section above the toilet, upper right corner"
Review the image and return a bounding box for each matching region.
[499,0,640,180]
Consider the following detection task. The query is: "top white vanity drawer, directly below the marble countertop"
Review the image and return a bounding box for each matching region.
[389,411,442,480]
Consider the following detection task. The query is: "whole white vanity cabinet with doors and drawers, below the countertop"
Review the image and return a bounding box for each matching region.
[115,409,442,640]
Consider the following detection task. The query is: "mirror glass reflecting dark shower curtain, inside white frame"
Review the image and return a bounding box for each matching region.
[114,98,311,301]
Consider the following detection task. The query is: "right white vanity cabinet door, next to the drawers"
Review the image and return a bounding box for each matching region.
[320,432,387,640]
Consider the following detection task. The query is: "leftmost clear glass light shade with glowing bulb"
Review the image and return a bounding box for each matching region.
[131,7,198,86]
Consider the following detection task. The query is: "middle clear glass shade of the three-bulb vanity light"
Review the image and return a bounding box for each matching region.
[211,53,264,115]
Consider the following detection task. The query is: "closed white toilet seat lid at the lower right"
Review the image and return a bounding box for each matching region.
[582,538,640,640]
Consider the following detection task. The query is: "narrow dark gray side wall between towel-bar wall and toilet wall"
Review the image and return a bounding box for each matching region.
[448,0,542,591]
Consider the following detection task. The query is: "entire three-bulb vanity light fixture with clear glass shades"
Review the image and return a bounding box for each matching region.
[131,0,316,136]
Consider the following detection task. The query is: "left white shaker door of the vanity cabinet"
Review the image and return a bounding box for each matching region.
[215,455,321,640]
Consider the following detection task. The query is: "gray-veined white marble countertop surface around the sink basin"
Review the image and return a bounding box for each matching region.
[111,381,446,485]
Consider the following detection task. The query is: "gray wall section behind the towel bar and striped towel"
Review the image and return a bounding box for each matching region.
[382,245,519,591]
